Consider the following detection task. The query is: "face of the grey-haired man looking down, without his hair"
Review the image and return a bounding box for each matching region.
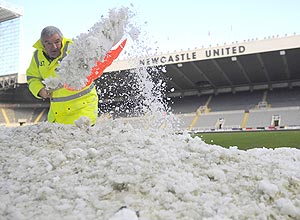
[43,34,62,58]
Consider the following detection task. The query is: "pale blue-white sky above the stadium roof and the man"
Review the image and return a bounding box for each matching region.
[2,0,300,71]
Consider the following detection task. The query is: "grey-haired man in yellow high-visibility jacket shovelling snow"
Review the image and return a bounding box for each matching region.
[26,26,98,124]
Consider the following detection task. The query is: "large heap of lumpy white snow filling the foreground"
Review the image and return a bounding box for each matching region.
[0,119,300,220]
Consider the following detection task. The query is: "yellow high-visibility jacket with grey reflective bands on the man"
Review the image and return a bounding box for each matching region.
[26,38,98,124]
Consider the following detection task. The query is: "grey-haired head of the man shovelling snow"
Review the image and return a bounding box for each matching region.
[40,26,63,58]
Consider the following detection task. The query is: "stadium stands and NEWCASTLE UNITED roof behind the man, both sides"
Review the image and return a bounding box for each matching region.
[0,3,300,131]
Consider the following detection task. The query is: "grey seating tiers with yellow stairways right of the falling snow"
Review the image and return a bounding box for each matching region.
[168,88,300,131]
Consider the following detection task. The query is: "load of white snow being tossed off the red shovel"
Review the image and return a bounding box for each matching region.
[44,7,137,89]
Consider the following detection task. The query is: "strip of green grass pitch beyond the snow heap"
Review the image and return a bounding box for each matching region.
[194,130,300,150]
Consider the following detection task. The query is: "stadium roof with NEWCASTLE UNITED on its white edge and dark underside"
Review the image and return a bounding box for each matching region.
[106,35,300,96]
